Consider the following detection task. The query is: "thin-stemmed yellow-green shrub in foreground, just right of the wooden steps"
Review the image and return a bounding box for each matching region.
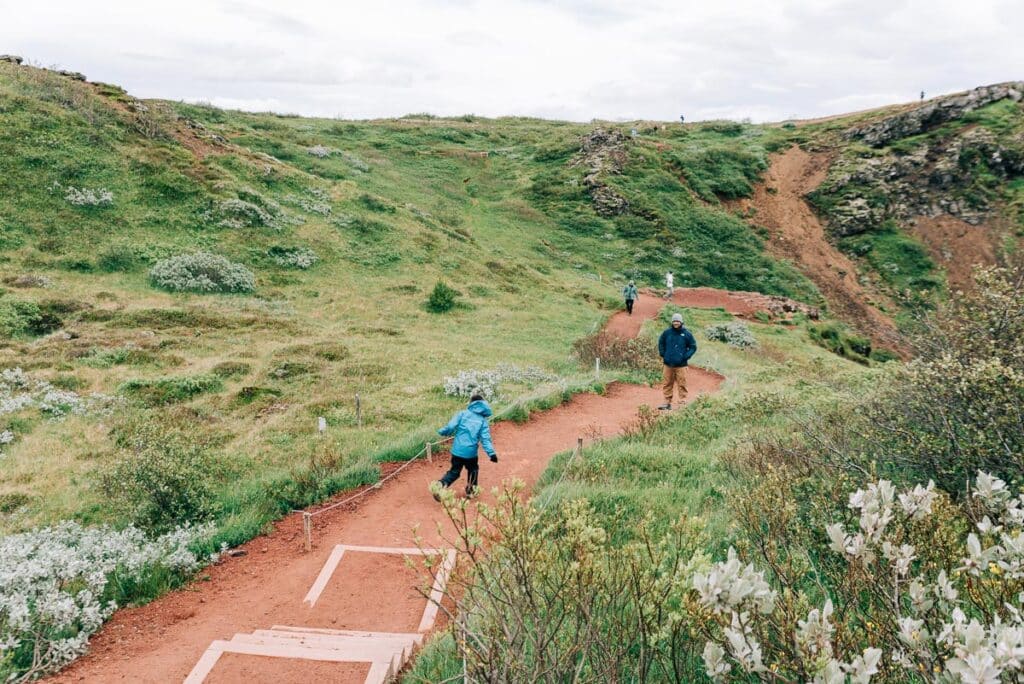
[413,488,703,683]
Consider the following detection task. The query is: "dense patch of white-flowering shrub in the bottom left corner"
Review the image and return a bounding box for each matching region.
[0,521,212,682]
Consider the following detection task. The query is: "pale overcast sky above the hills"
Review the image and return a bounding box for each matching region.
[0,0,1024,121]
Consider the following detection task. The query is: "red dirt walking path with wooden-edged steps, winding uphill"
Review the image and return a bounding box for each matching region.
[50,293,720,684]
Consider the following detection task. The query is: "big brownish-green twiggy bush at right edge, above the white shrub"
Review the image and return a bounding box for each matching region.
[866,262,1024,491]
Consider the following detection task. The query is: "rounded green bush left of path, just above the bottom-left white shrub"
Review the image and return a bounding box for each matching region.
[99,413,220,531]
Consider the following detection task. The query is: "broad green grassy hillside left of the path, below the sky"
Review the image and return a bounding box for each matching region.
[0,62,1021,540]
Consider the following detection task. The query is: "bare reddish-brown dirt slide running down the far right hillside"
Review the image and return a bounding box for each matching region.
[734,145,899,347]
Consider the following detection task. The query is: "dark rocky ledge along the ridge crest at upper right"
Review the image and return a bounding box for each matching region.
[847,81,1024,147]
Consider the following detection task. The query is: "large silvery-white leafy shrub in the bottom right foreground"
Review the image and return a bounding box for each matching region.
[693,472,1024,684]
